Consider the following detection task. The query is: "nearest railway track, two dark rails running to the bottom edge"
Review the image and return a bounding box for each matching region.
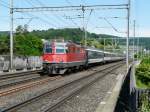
[2,62,123,112]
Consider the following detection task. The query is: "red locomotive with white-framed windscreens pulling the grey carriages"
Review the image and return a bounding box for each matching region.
[43,41,87,74]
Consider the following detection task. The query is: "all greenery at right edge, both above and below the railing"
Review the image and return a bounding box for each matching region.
[136,57,150,112]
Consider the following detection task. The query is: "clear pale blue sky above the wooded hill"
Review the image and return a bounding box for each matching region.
[0,0,150,37]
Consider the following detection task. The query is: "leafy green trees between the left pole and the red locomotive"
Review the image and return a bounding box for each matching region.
[14,26,42,56]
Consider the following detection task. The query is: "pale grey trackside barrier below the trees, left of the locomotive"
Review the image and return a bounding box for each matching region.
[0,55,42,72]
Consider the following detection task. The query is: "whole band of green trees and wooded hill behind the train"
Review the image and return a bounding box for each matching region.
[0,25,149,56]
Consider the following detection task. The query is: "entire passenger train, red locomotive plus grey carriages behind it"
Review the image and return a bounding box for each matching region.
[42,41,124,74]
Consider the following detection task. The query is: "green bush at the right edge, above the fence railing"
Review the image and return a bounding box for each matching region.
[136,57,150,88]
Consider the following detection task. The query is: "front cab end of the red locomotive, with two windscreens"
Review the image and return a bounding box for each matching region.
[43,42,66,74]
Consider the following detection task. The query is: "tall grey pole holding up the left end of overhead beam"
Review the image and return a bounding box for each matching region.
[10,0,13,71]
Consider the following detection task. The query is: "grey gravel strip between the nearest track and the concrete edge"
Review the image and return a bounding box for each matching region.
[52,64,126,112]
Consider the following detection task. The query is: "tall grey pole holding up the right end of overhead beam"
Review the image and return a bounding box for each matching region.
[126,0,130,72]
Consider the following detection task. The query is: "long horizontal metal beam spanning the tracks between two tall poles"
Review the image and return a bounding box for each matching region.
[13,4,128,12]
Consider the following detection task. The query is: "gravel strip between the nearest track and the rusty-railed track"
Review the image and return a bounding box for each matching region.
[0,64,122,110]
